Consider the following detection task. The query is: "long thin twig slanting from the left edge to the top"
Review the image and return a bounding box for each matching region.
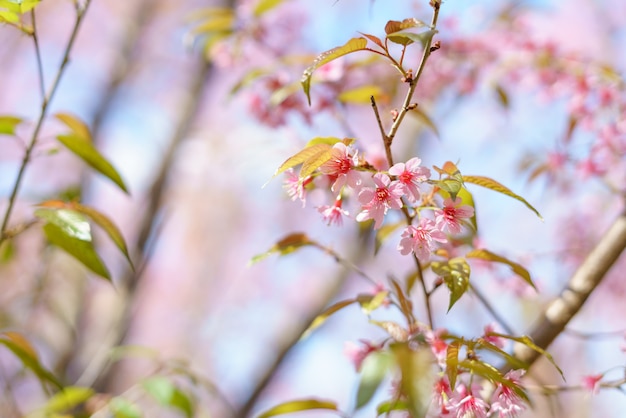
[0,0,91,243]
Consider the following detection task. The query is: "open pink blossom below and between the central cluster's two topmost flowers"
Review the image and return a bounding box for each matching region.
[356,173,404,229]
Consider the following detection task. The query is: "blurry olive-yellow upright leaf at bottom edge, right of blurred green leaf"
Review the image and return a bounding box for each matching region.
[391,344,435,418]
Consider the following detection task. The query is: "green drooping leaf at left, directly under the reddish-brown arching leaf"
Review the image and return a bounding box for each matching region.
[43,223,111,280]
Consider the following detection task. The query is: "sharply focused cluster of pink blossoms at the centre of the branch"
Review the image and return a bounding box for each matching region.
[284,142,474,262]
